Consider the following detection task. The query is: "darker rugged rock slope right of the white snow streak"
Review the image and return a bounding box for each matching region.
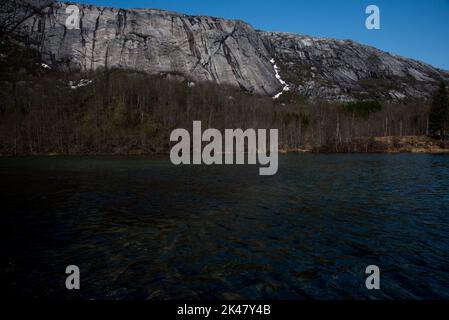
[260,32,449,100]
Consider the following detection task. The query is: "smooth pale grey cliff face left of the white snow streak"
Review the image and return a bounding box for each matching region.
[5,3,280,95]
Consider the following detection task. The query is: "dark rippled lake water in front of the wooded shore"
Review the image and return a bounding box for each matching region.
[0,155,449,299]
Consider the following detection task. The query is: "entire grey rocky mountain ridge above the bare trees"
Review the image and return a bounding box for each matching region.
[0,0,449,101]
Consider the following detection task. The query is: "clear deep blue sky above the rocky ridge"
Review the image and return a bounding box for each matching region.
[65,0,449,70]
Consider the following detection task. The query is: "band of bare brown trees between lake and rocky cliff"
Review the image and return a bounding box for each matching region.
[0,36,449,155]
